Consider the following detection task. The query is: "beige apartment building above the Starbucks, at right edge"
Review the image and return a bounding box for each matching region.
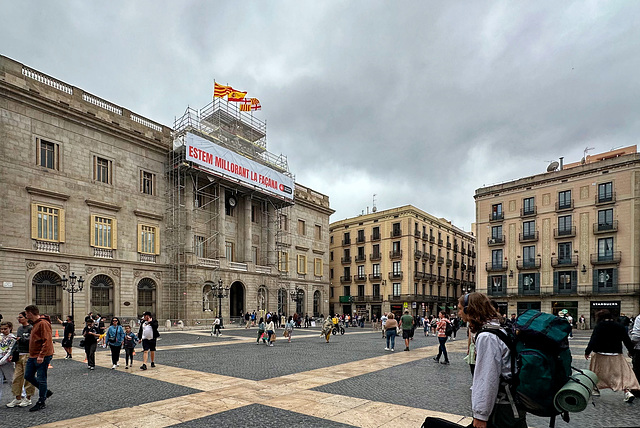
[475,146,640,325]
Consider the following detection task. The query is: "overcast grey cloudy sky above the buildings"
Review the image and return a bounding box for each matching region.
[0,0,640,230]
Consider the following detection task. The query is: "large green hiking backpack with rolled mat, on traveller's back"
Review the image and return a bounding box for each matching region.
[478,310,571,426]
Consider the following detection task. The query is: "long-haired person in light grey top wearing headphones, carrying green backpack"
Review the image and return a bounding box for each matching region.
[458,293,527,428]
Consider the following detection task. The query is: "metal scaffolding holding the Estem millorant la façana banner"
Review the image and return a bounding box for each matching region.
[163,99,294,324]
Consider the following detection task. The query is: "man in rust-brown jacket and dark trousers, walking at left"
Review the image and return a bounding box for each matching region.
[24,305,53,412]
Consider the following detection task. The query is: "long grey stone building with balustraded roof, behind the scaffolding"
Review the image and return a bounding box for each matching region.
[0,56,333,324]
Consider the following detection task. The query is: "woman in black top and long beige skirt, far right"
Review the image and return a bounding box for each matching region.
[588,309,640,403]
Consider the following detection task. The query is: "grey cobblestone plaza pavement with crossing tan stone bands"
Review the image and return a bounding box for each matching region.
[0,328,640,428]
